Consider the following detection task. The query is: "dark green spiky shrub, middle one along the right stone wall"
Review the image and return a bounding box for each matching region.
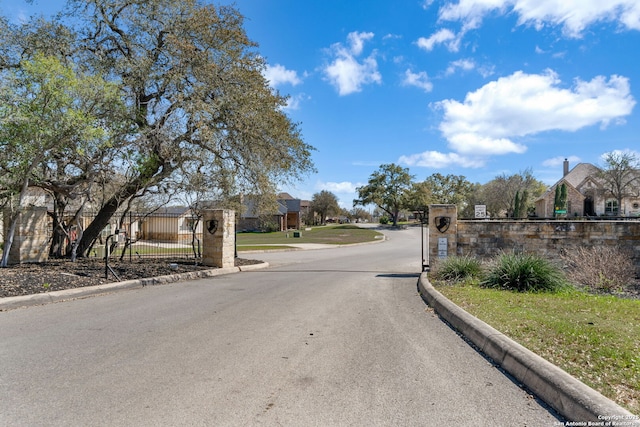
[481,253,569,292]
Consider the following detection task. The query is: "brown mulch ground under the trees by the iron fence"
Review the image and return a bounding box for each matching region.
[0,258,262,298]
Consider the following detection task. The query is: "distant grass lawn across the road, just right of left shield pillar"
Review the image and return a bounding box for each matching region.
[236,225,382,247]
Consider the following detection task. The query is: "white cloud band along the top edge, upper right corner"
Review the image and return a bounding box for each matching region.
[439,0,640,37]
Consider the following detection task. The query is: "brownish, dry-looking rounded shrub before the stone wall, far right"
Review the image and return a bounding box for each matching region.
[562,246,636,293]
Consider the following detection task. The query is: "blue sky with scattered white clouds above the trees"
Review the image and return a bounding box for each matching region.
[0,0,640,209]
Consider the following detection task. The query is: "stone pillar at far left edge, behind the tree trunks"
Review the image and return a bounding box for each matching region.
[3,207,51,264]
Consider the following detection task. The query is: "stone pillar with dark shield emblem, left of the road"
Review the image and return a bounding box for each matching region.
[202,209,236,268]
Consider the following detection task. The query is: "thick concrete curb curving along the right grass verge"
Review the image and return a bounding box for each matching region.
[418,273,640,427]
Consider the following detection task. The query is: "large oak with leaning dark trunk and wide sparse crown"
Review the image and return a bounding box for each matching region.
[0,0,313,254]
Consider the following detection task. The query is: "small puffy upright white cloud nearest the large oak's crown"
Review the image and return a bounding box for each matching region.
[324,32,382,95]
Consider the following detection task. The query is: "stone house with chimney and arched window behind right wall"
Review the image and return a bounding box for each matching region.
[536,159,640,217]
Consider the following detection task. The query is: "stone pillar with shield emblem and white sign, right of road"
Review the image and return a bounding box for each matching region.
[429,205,458,266]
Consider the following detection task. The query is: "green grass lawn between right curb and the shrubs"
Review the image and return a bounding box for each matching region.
[434,283,640,414]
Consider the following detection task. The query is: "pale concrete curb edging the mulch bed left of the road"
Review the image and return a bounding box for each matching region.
[0,262,269,311]
